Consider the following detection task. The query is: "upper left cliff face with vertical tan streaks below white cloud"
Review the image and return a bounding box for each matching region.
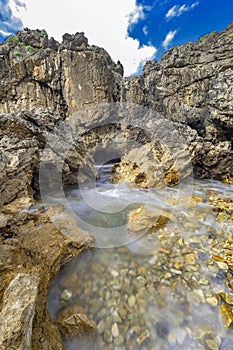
[0,29,121,117]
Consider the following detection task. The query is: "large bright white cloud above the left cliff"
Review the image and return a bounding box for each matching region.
[11,0,156,76]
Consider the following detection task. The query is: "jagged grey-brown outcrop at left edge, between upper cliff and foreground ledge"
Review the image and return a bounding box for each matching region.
[0,109,93,205]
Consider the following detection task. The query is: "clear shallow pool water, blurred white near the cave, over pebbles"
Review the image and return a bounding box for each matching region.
[48,171,233,350]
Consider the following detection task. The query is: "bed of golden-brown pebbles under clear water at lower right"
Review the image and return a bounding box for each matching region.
[48,181,233,350]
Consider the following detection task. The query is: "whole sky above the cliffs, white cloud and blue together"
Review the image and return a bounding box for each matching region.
[0,0,233,76]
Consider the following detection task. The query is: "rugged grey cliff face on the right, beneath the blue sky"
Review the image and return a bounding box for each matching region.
[122,23,233,179]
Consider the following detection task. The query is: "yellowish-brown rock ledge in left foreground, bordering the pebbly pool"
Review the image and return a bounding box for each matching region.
[0,198,93,350]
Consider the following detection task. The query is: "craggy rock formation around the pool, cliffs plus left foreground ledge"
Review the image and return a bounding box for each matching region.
[0,24,233,350]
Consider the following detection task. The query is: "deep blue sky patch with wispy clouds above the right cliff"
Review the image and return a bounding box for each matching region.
[128,0,233,59]
